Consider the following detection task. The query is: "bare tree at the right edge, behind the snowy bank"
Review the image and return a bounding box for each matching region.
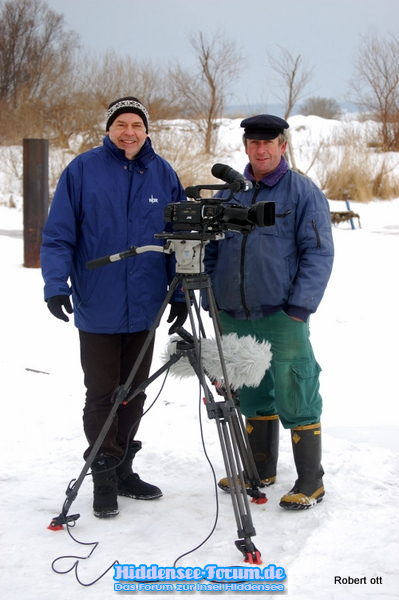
[351,34,399,151]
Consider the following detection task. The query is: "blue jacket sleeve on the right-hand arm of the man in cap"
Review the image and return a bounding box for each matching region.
[286,186,334,321]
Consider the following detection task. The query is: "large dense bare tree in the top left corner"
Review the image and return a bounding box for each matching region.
[0,0,79,143]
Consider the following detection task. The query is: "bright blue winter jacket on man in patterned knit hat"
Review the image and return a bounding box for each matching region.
[41,136,186,333]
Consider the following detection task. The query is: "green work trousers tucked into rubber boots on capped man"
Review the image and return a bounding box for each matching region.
[219,311,322,429]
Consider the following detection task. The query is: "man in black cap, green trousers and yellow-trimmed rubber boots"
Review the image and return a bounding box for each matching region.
[205,115,334,509]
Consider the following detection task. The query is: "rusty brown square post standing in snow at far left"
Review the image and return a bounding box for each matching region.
[23,139,49,268]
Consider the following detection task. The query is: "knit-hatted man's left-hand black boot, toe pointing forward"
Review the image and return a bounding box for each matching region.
[91,454,119,519]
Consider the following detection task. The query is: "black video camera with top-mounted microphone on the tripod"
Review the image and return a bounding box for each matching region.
[164,164,275,234]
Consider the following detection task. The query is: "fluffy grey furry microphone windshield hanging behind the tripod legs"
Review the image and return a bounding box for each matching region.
[161,333,272,390]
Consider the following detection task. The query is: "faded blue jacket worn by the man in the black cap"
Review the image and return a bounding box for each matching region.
[205,159,334,321]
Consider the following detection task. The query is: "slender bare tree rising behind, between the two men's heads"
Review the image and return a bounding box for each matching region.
[170,32,244,154]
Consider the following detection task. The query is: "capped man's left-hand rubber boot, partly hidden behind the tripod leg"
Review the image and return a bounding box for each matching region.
[218,415,280,492]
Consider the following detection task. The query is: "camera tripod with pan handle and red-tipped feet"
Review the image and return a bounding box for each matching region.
[49,232,267,564]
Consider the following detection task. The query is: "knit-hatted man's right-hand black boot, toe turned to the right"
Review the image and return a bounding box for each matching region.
[116,441,162,500]
